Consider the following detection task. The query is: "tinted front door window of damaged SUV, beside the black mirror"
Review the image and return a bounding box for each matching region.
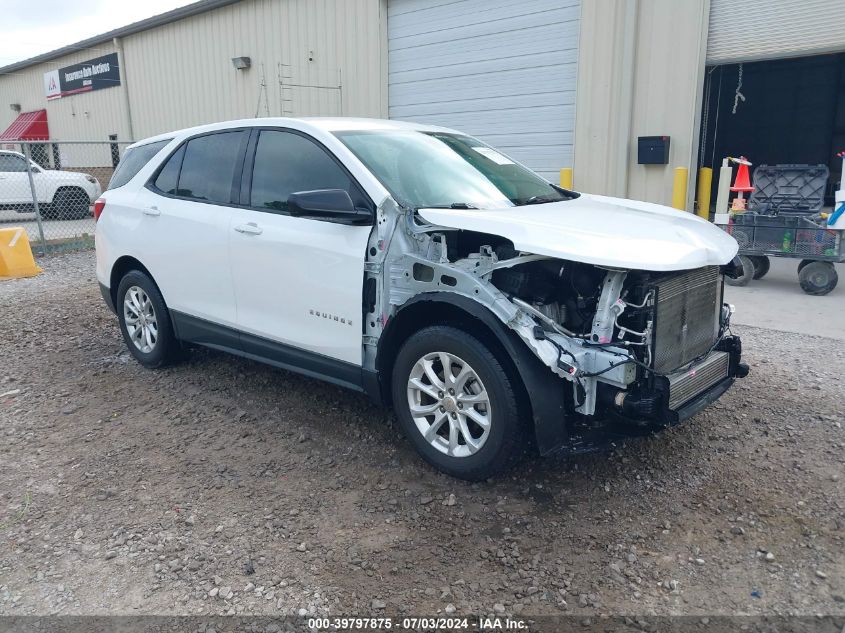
[249,130,370,213]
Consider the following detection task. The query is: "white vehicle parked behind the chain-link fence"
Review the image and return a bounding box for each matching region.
[0,150,102,220]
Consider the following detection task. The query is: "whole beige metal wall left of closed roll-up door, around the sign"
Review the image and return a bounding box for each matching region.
[0,0,387,146]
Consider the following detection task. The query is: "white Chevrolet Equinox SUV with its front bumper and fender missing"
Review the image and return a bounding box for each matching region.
[94,118,748,479]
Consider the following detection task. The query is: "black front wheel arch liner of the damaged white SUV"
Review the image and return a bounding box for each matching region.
[376,292,571,455]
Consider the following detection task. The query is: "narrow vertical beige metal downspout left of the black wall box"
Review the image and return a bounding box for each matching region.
[613,0,639,198]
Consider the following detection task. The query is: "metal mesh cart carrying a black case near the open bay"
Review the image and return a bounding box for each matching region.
[721,165,845,295]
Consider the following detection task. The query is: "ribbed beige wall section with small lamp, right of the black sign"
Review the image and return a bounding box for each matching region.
[123,0,386,137]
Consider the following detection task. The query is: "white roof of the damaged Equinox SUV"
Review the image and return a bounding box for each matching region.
[129,117,458,148]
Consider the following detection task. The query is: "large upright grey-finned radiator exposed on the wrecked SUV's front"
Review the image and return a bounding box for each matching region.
[654,266,721,374]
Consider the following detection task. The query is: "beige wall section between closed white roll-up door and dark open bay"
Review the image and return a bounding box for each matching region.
[574,0,710,210]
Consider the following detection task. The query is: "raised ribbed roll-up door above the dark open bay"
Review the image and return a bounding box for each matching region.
[707,0,845,65]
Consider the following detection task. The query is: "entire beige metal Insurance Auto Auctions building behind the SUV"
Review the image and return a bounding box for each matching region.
[0,0,845,210]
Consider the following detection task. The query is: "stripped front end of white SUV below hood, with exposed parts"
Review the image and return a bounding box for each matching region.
[364,197,748,454]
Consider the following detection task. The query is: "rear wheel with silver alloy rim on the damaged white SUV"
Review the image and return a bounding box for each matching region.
[115,270,179,369]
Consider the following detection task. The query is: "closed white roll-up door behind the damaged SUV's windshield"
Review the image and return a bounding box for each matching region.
[387,0,580,181]
